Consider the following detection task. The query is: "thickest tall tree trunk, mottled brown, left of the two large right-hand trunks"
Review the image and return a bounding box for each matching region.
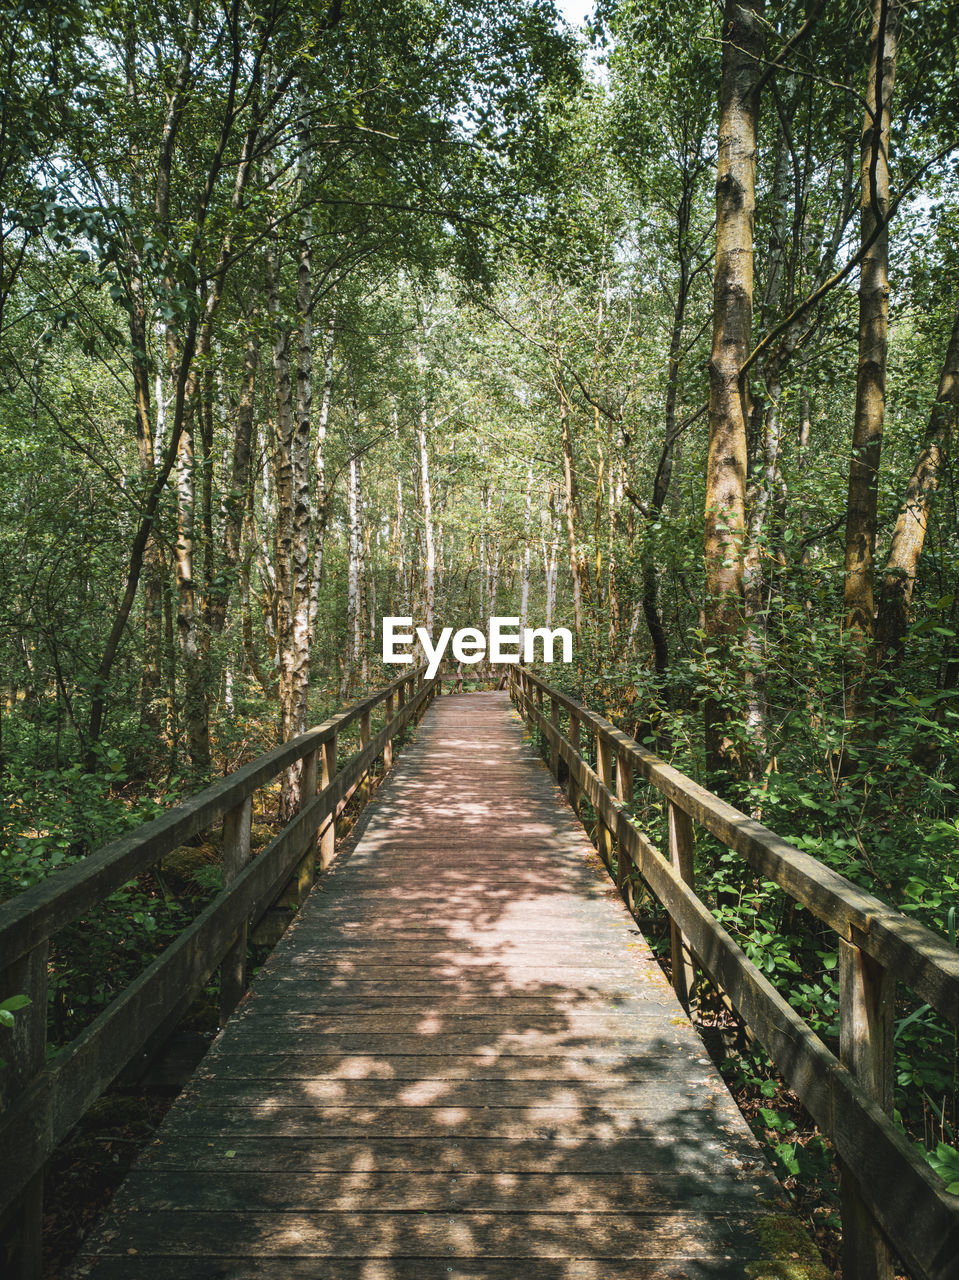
[704,0,763,773]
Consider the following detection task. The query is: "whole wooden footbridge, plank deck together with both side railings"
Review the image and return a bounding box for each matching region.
[0,669,959,1280]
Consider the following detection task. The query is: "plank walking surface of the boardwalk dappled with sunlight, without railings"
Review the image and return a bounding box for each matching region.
[79,694,826,1280]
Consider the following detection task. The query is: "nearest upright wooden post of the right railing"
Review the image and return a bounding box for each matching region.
[839,938,896,1280]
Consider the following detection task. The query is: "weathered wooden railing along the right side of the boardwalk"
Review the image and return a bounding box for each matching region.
[510,667,959,1280]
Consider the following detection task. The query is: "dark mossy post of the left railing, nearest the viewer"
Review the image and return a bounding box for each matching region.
[0,941,50,1280]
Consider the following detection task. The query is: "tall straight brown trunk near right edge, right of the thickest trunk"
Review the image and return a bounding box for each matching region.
[844,0,899,637]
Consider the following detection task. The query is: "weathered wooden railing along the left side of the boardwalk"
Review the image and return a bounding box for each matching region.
[0,666,437,1280]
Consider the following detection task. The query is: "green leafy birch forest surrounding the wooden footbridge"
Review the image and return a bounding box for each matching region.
[0,0,959,1274]
